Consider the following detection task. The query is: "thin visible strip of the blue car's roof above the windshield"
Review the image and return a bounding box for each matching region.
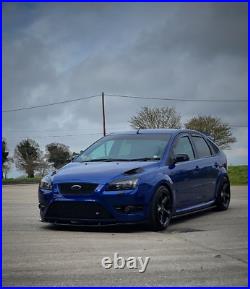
[108,128,205,136]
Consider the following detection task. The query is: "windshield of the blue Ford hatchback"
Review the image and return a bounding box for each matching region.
[74,134,170,162]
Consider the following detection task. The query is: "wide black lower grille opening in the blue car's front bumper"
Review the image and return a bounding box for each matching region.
[46,201,113,219]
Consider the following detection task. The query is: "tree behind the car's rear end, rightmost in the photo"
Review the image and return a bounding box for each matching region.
[185,116,236,149]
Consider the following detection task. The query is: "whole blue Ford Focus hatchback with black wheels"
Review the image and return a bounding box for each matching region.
[39,129,230,230]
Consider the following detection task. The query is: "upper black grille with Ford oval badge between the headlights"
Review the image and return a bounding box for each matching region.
[59,183,98,195]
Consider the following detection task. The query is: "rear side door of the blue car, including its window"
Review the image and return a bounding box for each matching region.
[192,134,219,203]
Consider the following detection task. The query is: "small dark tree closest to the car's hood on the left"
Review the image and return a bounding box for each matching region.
[46,143,71,169]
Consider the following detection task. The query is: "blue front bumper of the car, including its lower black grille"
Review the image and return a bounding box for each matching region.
[39,184,148,225]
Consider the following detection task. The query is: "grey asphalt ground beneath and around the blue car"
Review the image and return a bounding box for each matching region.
[3,185,248,286]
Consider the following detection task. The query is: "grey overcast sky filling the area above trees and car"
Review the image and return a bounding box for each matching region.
[3,3,248,175]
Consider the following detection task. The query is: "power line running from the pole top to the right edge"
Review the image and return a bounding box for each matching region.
[105,93,247,102]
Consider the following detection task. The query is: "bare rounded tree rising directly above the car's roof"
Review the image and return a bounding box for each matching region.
[129,106,181,129]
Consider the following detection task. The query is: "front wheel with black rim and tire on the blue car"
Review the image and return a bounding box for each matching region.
[149,186,172,231]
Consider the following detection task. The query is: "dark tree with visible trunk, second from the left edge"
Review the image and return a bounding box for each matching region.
[14,139,42,178]
